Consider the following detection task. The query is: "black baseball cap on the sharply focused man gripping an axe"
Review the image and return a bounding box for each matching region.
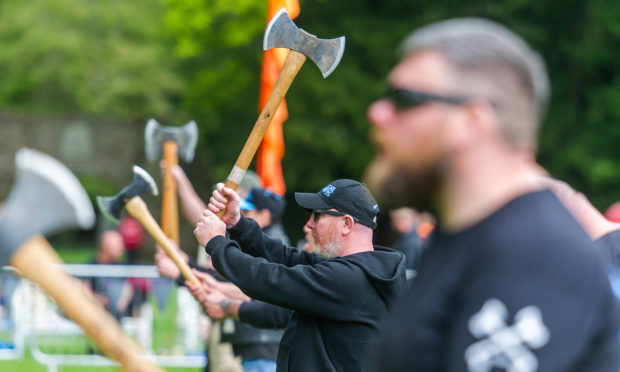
[295,179,379,229]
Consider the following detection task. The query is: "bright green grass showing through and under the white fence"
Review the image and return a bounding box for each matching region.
[0,249,202,372]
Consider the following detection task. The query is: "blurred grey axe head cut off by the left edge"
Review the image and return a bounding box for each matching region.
[0,148,95,266]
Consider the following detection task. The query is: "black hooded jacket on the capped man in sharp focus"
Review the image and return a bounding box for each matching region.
[206,217,407,372]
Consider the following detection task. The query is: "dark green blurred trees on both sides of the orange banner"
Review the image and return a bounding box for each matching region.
[162,0,620,241]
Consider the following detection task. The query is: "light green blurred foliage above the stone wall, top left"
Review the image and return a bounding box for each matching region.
[0,0,183,119]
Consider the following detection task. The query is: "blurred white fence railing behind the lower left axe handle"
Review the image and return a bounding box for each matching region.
[0,265,208,372]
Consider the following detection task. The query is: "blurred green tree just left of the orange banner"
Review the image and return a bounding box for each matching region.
[163,0,267,180]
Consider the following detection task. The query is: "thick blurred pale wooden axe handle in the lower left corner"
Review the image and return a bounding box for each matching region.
[10,235,163,372]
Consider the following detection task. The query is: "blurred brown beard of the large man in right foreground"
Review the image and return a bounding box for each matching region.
[364,158,443,213]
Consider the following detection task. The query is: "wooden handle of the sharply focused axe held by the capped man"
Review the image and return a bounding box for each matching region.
[217,49,306,219]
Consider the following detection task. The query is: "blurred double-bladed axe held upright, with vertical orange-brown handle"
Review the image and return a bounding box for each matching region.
[144,119,198,245]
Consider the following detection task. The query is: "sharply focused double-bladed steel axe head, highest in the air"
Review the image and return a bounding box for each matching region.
[263,8,344,78]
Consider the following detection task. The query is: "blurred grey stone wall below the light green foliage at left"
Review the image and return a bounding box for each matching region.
[0,114,211,260]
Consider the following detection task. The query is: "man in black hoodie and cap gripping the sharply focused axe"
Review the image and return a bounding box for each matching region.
[194,179,406,371]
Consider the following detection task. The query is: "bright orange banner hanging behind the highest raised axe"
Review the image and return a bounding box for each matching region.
[256,0,300,195]
